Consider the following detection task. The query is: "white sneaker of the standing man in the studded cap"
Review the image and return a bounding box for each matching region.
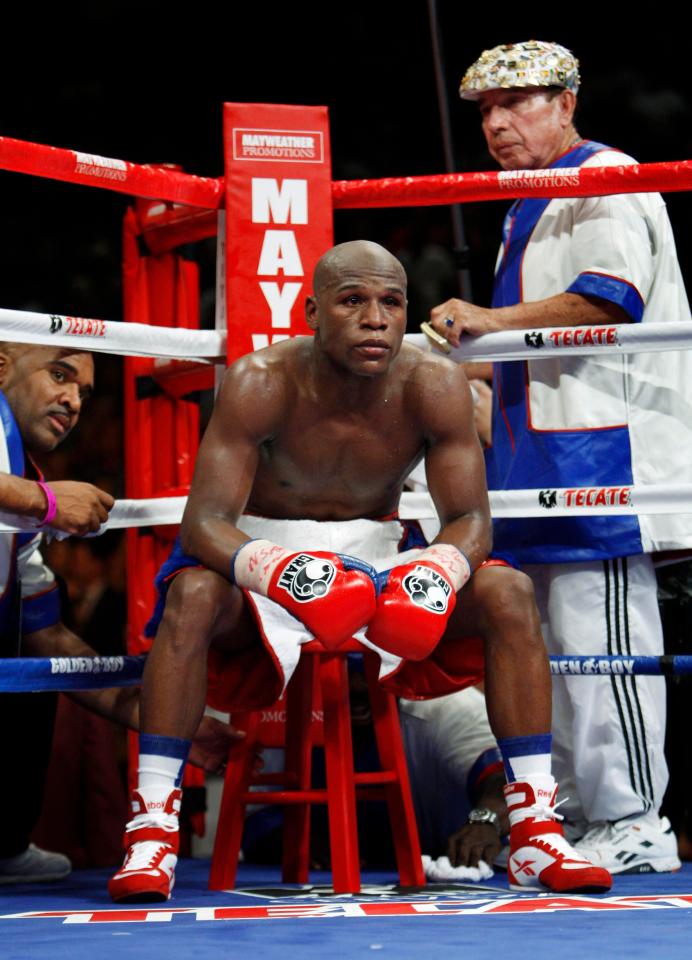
[574,814,680,873]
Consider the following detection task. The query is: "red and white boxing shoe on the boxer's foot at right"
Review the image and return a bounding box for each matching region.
[504,777,612,893]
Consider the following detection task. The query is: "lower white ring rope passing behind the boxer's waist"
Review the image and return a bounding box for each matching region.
[0,483,692,538]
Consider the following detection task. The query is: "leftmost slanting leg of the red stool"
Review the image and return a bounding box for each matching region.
[209,712,260,890]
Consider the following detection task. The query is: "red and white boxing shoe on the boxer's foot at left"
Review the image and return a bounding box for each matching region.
[108,787,182,903]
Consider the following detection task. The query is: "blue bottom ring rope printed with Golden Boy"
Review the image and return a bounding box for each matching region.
[0,656,692,693]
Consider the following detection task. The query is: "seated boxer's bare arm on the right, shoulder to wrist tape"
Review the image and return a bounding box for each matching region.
[418,358,492,570]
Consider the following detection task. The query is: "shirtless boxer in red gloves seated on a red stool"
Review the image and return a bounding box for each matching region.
[109,241,610,900]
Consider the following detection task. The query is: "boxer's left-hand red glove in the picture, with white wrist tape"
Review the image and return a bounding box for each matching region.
[233,540,377,649]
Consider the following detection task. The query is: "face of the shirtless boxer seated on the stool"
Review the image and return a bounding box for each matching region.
[307,259,406,377]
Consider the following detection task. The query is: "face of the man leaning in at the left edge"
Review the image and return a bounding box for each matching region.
[0,347,94,453]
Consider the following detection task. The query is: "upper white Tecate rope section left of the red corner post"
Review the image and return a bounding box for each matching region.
[0,308,226,363]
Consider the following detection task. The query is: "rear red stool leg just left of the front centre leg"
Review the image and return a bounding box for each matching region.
[282,656,315,883]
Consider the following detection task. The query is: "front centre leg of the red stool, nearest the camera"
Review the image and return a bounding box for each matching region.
[320,654,360,893]
